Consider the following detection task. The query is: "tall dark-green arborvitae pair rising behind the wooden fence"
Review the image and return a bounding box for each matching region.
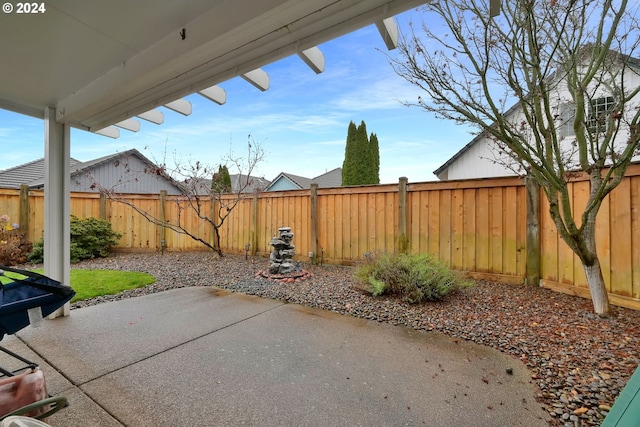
[342,121,380,186]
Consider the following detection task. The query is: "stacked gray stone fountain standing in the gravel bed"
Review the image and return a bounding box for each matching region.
[256,227,311,283]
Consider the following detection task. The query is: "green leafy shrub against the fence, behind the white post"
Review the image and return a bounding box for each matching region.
[29,215,122,263]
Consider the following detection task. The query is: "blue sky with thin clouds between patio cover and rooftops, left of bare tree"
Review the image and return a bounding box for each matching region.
[0,11,472,183]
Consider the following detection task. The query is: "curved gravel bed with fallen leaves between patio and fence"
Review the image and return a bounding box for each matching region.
[72,252,640,427]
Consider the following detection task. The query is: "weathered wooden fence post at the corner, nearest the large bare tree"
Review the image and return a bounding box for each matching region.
[524,176,540,286]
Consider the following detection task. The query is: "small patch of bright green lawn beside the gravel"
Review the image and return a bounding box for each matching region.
[0,269,156,302]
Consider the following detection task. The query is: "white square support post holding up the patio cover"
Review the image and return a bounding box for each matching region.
[44,107,71,318]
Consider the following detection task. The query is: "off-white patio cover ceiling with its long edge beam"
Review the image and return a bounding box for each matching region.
[0,0,424,135]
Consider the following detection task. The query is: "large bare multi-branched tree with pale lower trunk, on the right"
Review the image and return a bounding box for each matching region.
[391,0,640,316]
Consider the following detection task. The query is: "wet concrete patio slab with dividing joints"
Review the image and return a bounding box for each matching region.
[1,288,548,427]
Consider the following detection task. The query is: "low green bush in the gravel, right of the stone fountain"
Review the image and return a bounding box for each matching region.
[355,253,471,304]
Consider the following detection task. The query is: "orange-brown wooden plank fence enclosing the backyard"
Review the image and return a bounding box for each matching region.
[0,165,640,309]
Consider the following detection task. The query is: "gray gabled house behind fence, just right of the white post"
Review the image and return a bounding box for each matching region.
[71,156,180,194]
